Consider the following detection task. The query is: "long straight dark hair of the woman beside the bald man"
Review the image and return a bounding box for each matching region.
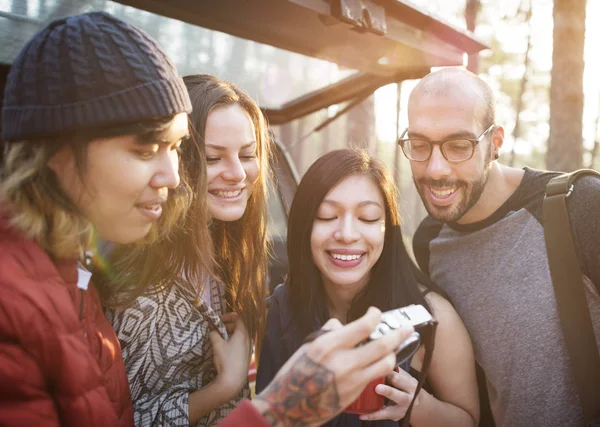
[286,149,430,336]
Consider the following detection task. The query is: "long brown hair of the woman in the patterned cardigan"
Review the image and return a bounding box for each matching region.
[183,74,271,336]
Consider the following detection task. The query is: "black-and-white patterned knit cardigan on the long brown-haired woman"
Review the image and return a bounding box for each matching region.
[106,279,249,427]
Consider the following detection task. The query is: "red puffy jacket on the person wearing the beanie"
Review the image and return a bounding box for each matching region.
[0,215,133,426]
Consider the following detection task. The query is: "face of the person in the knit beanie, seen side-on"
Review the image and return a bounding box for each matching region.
[49,113,188,244]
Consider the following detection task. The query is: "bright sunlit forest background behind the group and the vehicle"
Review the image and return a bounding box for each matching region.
[0,0,600,238]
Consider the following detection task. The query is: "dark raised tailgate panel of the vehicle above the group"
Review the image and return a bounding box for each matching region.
[117,0,487,76]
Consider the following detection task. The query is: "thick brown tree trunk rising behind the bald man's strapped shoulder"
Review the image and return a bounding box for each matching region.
[546,0,586,172]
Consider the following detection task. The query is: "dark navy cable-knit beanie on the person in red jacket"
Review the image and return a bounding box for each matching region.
[2,12,192,141]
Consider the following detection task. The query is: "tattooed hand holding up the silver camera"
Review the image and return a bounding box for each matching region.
[252,308,412,426]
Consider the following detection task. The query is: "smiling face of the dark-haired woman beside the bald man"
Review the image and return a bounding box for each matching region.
[310,175,385,295]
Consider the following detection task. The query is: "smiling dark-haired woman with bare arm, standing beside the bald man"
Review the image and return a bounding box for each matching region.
[257,149,479,427]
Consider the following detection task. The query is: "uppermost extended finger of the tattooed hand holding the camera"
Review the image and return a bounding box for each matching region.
[307,307,381,361]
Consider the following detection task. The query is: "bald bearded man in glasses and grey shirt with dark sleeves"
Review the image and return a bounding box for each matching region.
[399,68,600,427]
